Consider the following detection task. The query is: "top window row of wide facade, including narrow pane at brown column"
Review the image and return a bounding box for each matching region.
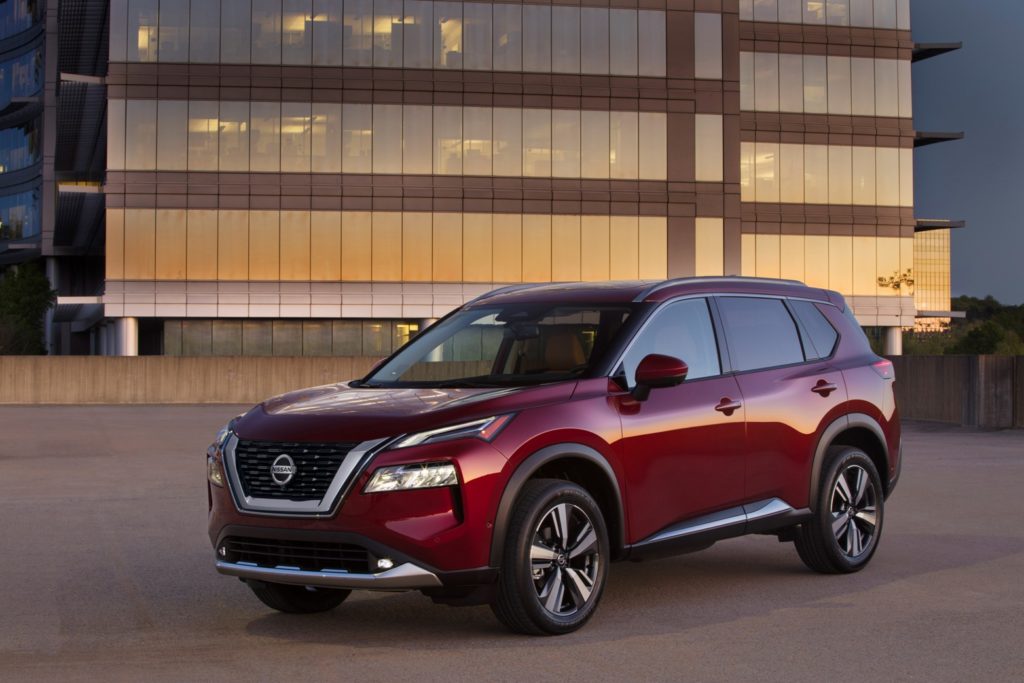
[110,0,663,78]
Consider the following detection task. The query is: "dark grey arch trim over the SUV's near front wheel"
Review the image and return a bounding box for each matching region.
[490,443,626,567]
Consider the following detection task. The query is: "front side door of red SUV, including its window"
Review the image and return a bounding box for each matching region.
[611,298,744,541]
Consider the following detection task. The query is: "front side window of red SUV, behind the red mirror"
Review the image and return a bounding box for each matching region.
[623,299,722,388]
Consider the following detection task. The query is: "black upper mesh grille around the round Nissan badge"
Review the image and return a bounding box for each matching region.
[234,440,356,501]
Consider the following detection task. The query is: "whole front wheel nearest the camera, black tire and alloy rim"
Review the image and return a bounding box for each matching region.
[490,479,610,636]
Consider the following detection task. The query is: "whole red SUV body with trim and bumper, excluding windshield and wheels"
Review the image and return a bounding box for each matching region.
[208,278,900,618]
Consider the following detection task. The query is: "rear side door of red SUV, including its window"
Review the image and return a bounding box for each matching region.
[716,296,846,509]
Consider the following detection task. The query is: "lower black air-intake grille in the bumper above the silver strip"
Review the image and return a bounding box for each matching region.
[220,537,370,573]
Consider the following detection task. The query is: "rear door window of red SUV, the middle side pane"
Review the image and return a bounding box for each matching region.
[718,297,804,372]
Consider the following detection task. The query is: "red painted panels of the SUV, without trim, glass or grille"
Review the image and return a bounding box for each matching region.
[209,280,899,589]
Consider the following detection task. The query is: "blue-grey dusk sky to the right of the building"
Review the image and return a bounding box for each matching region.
[911,0,1024,304]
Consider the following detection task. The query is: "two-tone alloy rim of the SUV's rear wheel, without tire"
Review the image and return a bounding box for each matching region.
[830,465,878,560]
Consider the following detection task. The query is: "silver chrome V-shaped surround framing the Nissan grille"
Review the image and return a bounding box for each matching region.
[223,434,388,517]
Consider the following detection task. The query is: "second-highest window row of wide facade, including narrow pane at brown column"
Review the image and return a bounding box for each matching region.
[114,99,671,180]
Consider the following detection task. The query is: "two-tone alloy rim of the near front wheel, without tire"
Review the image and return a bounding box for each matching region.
[529,503,601,616]
